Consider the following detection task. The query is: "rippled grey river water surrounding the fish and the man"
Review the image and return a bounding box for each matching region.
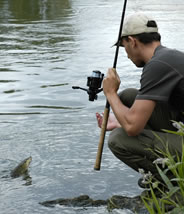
[0,0,184,214]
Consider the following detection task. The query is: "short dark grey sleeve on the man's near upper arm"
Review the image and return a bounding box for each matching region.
[136,60,181,102]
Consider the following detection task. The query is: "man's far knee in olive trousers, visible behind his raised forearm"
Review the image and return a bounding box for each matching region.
[119,88,138,107]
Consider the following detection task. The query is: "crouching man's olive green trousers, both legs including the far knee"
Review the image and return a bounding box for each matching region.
[108,89,182,180]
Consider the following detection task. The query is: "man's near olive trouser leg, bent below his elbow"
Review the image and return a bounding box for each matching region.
[108,128,182,180]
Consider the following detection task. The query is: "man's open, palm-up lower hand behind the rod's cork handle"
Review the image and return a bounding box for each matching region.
[96,112,121,131]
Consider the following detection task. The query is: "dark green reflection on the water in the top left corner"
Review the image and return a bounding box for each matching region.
[0,0,71,23]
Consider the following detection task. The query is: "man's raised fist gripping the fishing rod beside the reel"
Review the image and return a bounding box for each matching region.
[103,68,121,97]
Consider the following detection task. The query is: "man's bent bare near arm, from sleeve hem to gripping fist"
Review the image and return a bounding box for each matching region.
[103,68,156,136]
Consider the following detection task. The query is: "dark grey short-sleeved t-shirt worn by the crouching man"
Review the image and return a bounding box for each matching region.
[136,45,184,111]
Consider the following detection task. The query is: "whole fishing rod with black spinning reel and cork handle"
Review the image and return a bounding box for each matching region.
[72,0,127,170]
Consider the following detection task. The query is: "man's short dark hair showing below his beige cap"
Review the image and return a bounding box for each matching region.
[121,32,161,44]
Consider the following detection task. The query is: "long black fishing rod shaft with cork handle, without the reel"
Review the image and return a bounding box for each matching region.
[94,0,127,170]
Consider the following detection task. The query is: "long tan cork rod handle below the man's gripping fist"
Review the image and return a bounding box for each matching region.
[94,105,110,170]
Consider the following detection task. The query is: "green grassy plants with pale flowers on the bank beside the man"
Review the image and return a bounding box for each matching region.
[142,122,184,214]
